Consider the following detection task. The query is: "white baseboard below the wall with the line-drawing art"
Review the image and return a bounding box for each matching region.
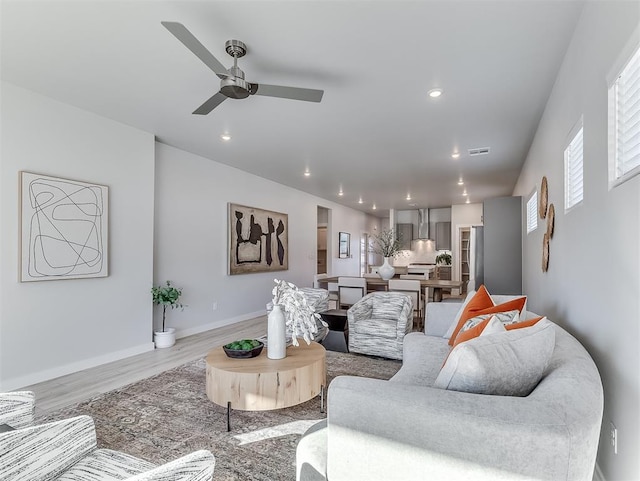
[2,342,155,391]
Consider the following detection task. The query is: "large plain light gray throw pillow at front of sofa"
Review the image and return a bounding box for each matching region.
[434,319,556,396]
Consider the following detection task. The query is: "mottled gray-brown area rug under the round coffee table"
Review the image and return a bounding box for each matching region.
[38,351,401,481]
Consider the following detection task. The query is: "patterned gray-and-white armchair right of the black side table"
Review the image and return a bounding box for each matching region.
[347,291,413,359]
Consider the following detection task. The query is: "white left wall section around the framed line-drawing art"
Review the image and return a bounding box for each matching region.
[0,82,154,390]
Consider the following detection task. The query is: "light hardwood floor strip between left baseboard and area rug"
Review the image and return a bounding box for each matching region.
[24,316,267,415]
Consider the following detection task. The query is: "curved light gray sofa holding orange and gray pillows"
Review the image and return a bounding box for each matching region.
[296,303,603,481]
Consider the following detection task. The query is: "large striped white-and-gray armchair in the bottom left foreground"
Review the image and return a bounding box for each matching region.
[0,416,215,481]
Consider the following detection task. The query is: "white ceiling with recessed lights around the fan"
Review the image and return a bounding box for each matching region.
[1,0,583,216]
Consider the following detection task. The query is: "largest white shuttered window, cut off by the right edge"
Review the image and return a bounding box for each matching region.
[609,43,640,185]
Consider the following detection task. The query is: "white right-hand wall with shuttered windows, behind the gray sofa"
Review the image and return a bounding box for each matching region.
[514,2,640,481]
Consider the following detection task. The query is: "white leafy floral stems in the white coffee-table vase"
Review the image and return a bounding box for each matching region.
[272,279,324,346]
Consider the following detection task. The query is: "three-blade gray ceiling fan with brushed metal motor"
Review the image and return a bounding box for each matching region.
[161,22,324,115]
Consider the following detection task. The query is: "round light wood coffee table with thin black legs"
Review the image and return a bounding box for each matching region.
[206,341,327,430]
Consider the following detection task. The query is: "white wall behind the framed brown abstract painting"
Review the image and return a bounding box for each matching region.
[154,143,370,337]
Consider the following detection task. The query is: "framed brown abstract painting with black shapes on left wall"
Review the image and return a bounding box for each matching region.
[229,203,289,275]
